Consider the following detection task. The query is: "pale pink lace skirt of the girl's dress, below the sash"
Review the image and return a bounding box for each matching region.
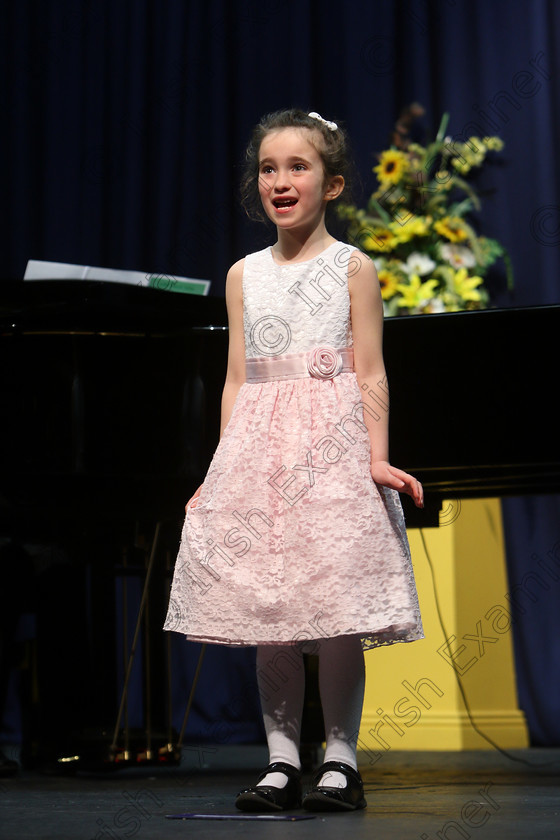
[165,352,423,649]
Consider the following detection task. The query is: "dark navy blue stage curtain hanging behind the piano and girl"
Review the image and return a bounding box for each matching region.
[0,0,560,744]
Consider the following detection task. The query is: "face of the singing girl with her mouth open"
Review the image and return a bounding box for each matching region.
[259,128,344,229]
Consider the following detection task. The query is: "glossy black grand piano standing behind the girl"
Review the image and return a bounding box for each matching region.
[0,280,560,776]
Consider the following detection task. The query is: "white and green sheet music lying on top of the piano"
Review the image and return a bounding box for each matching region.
[23,260,210,296]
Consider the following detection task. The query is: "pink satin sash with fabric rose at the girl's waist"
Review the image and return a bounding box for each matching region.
[245,347,354,383]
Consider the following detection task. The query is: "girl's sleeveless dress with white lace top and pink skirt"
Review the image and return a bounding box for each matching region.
[165,242,423,649]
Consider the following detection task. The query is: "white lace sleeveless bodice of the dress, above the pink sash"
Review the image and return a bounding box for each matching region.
[243,242,355,358]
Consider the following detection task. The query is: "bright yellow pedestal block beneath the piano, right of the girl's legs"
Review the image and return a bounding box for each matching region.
[358,499,529,762]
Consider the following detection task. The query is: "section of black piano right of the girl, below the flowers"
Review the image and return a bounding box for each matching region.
[385,305,560,506]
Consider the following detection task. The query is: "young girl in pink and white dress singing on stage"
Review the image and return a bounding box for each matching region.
[165,110,423,811]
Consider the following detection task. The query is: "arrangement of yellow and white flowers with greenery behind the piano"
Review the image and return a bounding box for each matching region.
[338,106,512,315]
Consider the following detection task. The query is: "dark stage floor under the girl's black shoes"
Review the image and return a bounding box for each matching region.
[0,746,560,840]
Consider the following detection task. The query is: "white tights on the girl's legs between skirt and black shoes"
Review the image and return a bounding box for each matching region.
[257,636,365,788]
